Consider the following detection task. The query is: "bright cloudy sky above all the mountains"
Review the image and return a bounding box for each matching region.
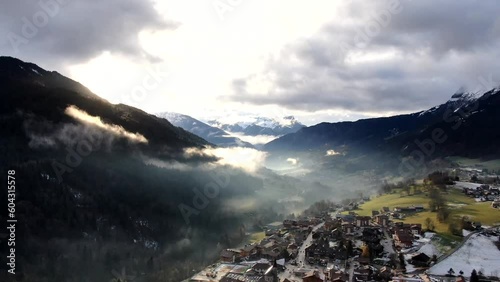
[0,0,500,125]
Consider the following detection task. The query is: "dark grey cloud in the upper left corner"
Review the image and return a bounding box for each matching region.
[0,0,176,66]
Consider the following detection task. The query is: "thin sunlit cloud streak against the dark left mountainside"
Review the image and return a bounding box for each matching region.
[64,106,148,143]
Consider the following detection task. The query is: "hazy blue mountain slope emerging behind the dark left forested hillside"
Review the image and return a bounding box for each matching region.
[156,112,253,148]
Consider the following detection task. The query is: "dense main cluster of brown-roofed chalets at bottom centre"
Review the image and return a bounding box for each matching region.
[189,203,500,282]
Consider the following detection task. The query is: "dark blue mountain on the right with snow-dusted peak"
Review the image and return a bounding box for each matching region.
[264,88,500,164]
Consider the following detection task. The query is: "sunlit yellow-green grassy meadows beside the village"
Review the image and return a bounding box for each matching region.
[356,189,500,239]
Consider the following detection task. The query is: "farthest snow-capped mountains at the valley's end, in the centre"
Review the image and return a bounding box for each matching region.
[207,116,305,137]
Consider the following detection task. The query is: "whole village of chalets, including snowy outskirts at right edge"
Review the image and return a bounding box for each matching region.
[186,176,500,282]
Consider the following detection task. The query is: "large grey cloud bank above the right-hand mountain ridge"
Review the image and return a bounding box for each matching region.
[230,0,500,112]
